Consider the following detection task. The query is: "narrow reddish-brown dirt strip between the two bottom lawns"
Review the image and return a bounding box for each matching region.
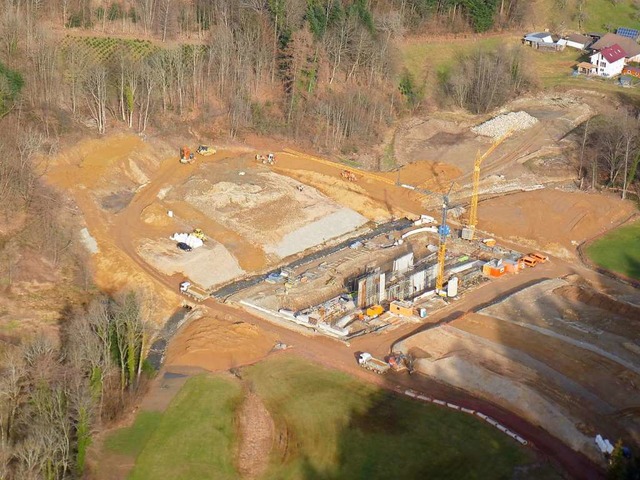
[238,392,274,479]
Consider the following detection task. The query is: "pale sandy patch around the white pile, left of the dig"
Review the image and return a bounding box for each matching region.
[137,239,244,288]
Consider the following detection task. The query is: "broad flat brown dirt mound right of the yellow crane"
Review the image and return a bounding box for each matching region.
[478,189,634,258]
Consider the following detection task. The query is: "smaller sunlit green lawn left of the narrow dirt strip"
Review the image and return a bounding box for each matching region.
[106,375,241,480]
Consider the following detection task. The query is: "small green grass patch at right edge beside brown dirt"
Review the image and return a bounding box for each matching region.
[587,222,640,280]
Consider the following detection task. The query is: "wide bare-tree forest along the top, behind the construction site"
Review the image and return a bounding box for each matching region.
[0,0,528,149]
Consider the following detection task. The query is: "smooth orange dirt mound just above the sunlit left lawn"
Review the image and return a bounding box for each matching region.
[166,317,275,371]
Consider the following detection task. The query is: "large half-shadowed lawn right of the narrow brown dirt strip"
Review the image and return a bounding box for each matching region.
[245,358,556,480]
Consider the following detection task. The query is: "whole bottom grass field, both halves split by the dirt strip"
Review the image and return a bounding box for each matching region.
[106,357,560,480]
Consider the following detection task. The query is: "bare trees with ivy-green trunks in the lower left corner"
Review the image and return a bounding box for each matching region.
[0,292,148,480]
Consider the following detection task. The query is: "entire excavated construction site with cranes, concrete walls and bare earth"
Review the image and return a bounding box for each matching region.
[42,90,640,468]
